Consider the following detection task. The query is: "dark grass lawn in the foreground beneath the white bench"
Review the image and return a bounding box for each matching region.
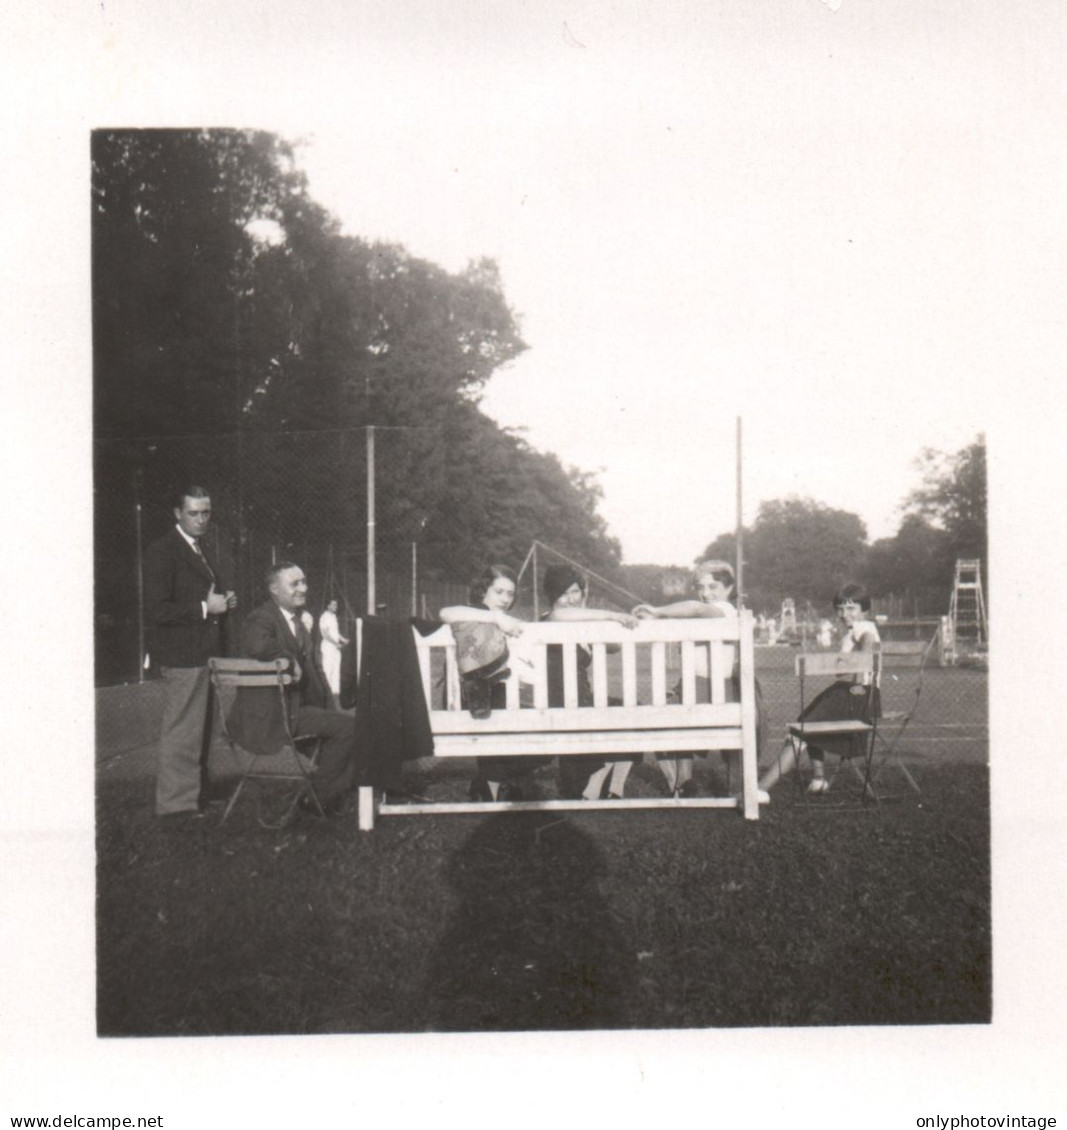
[97,747,991,1035]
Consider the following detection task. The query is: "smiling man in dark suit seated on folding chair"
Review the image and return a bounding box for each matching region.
[229,562,355,815]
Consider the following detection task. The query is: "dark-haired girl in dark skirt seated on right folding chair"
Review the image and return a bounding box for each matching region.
[760,584,882,793]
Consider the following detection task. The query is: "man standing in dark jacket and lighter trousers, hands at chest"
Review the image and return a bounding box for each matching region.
[145,486,237,817]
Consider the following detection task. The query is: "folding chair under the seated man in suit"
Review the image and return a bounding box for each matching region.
[208,659,326,828]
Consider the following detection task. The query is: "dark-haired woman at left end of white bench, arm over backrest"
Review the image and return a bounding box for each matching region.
[439,565,542,800]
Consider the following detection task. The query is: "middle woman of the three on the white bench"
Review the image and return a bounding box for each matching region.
[541,565,637,800]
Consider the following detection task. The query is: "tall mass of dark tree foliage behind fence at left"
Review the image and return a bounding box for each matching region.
[92,130,619,601]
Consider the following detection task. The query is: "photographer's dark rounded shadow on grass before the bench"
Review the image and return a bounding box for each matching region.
[423,812,635,1032]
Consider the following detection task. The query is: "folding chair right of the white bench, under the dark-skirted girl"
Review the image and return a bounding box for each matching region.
[789,649,882,803]
